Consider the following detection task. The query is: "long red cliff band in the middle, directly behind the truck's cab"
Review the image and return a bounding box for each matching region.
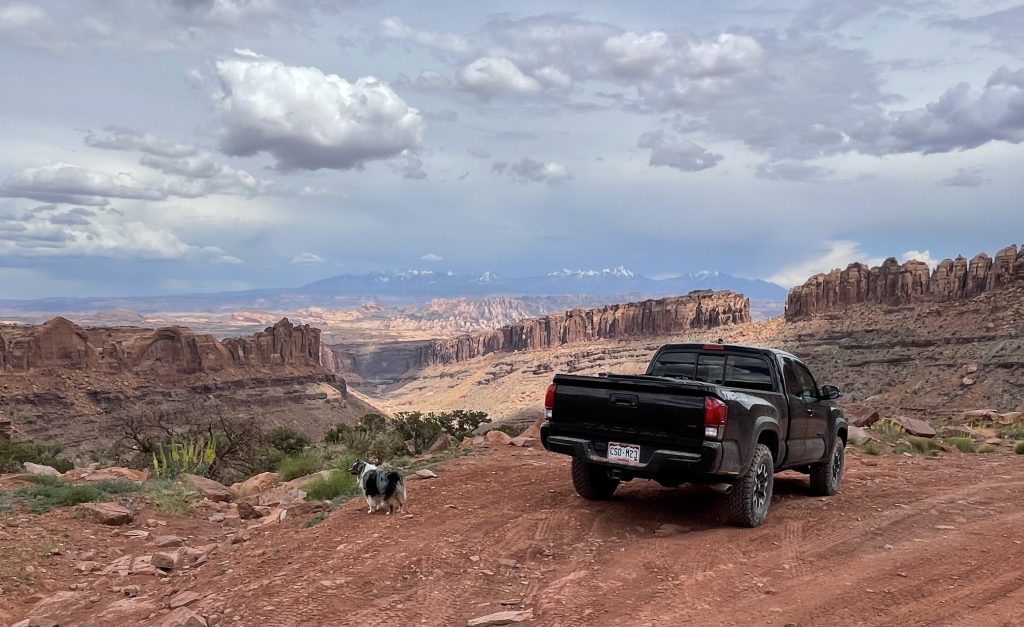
[415,290,751,367]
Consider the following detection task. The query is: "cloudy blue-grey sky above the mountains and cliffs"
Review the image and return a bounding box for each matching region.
[0,0,1024,298]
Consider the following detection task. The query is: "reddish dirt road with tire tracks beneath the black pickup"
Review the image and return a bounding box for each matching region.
[6,449,1024,626]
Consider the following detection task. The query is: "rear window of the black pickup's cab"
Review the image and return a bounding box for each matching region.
[648,350,775,391]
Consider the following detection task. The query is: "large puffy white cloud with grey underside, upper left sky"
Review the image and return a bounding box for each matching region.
[207,51,423,171]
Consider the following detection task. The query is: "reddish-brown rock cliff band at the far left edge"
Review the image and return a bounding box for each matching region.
[0,318,321,375]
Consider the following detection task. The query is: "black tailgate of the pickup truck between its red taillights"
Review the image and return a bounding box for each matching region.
[550,375,710,452]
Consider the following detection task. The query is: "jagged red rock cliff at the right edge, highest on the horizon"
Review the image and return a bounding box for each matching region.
[785,245,1024,320]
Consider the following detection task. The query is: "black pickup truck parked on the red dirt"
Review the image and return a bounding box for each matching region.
[541,343,847,527]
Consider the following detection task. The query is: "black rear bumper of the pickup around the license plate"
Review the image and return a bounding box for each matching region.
[541,423,739,483]
